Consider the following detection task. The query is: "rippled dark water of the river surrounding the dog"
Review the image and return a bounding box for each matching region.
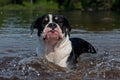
[0,10,120,80]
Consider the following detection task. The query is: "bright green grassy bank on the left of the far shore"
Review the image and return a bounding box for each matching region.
[0,1,58,10]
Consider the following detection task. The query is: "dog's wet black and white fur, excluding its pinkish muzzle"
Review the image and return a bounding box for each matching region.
[31,14,96,68]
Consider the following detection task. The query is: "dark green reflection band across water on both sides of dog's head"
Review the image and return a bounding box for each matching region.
[0,10,120,31]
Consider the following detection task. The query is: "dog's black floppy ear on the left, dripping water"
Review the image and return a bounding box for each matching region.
[30,17,42,36]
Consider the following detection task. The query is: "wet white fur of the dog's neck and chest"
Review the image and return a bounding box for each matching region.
[45,35,72,67]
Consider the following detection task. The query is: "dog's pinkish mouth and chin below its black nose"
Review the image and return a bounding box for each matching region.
[43,28,62,45]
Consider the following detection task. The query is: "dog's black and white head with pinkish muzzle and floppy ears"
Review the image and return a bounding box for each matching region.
[31,14,71,40]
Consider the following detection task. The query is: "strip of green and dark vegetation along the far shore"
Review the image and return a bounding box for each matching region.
[0,0,120,11]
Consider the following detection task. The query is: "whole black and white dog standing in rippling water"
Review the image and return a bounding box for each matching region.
[31,14,96,68]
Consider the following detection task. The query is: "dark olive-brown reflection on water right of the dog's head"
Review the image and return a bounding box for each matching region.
[60,12,120,31]
